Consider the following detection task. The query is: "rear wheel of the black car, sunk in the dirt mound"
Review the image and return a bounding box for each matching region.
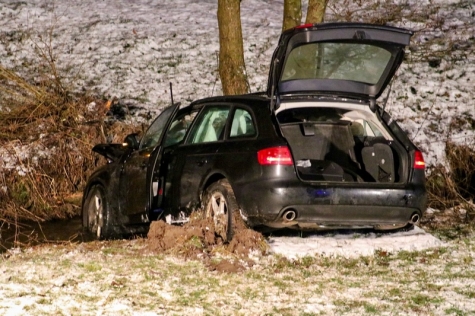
[203,179,238,242]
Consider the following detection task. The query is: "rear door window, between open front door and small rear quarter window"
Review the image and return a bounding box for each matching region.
[190,106,229,144]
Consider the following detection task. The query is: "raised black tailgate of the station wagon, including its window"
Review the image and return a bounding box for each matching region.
[268,23,413,106]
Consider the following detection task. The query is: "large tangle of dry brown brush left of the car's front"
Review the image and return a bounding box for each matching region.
[0,66,136,222]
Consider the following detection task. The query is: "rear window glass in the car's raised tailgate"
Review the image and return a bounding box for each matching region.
[281,42,392,85]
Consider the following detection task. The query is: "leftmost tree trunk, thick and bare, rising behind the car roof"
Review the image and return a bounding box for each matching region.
[218,0,248,95]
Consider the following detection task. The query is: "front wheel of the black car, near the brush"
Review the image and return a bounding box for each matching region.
[83,184,109,239]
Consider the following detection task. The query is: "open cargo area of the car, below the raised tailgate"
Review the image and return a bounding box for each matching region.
[278,108,404,183]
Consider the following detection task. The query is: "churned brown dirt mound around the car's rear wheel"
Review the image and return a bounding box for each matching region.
[147,215,267,272]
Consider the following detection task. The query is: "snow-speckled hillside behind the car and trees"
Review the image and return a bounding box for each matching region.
[0,0,475,168]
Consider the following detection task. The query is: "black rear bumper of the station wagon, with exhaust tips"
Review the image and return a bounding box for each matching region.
[235,181,427,230]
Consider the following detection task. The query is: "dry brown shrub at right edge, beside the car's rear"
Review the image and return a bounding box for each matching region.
[426,142,475,217]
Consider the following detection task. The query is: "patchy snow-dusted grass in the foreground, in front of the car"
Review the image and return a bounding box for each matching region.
[0,236,475,315]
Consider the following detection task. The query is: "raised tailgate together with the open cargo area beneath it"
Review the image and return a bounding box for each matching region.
[268,23,413,183]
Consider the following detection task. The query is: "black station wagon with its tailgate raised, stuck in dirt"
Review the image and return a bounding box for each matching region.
[82,23,426,240]
